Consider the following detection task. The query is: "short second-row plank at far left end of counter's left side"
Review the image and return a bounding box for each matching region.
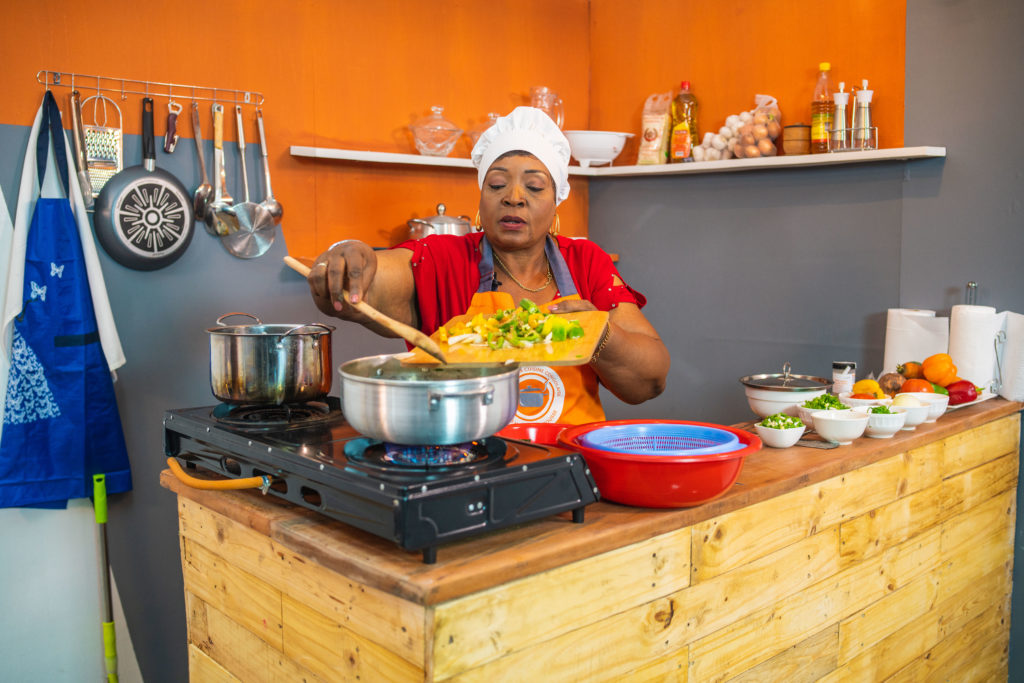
[184,540,282,651]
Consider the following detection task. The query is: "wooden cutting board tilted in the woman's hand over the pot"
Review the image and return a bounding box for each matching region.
[402,310,608,367]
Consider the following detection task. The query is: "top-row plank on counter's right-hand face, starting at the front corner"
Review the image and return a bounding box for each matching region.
[432,528,690,678]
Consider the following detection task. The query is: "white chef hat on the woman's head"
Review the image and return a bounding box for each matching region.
[471,106,570,204]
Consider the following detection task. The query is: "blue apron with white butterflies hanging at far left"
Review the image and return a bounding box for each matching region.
[0,91,131,508]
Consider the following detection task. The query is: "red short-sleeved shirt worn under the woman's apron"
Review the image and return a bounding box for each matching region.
[394,232,647,334]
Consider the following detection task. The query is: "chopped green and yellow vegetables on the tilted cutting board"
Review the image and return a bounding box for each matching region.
[437,299,584,351]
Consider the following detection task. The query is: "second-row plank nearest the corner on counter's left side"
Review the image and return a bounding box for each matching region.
[283,596,426,681]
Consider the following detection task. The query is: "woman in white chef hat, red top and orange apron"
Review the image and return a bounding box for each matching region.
[308,106,669,424]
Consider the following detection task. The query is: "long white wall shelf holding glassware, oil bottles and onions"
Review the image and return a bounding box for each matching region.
[291,145,946,178]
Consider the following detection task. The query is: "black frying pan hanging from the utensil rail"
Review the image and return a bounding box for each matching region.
[95,97,196,270]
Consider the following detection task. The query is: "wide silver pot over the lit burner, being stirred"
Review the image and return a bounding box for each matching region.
[339,355,519,445]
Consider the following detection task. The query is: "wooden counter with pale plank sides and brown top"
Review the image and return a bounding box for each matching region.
[161,398,1022,683]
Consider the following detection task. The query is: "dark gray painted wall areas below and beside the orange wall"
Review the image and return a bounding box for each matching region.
[0,0,1024,682]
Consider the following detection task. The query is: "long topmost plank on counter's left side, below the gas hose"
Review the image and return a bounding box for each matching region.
[179,499,425,667]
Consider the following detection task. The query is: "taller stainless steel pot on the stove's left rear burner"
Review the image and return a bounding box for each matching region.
[207,312,334,404]
